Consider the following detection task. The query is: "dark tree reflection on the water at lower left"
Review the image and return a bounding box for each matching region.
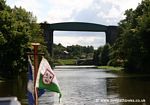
[0,73,27,104]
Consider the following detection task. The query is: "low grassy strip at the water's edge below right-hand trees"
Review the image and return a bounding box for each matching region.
[97,66,123,72]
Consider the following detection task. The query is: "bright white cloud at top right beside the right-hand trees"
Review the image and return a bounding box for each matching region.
[98,0,142,23]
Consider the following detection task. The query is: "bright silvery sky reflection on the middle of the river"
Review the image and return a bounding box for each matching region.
[55,68,116,105]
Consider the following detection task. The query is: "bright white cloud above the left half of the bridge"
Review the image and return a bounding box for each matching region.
[46,0,93,23]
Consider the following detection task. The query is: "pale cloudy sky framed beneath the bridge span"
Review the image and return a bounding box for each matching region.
[54,32,106,48]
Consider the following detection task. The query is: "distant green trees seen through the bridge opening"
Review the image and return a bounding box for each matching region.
[53,44,94,59]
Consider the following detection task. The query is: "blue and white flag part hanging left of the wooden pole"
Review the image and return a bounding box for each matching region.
[27,57,34,105]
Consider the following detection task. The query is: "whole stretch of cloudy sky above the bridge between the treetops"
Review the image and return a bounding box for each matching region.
[7,0,142,25]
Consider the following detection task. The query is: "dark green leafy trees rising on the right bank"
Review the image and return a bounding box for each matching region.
[111,0,150,71]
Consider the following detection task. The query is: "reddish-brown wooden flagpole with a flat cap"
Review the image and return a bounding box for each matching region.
[32,43,40,105]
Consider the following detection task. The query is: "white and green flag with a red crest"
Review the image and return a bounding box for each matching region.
[36,57,62,99]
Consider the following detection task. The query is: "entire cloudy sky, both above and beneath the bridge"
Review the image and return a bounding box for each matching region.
[6,0,142,48]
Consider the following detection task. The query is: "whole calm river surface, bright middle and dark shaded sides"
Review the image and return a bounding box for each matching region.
[0,66,150,105]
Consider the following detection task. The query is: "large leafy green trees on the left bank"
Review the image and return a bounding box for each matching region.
[0,0,47,75]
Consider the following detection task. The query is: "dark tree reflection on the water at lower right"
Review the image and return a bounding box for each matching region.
[107,77,150,105]
